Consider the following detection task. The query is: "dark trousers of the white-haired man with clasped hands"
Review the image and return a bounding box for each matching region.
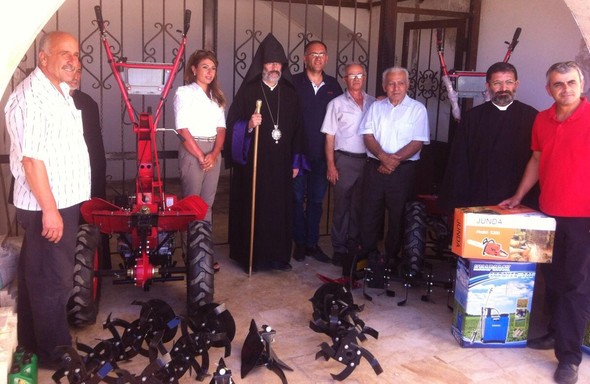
[361,159,416,263]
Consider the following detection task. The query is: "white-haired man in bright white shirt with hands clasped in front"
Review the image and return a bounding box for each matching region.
[359,67,430,272]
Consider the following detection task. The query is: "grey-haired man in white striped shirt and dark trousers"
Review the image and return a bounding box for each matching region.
[4,31,90,369]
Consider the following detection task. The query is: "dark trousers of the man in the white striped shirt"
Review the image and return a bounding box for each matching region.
[16,205,80,363]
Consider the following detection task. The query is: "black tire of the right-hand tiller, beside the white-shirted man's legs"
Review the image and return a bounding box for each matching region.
[402,201,427,275]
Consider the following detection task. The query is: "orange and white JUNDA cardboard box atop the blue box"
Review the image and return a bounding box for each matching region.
[452,206,555,263]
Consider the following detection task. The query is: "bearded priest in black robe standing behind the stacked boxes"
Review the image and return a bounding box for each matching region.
[438,62,539,213]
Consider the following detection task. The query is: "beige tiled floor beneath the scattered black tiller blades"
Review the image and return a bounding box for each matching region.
[39,237,590,384]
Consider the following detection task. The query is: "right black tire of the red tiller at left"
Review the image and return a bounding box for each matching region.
[185,221,215,317]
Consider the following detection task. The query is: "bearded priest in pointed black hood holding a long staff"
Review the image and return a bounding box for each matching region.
[225,34,309,270]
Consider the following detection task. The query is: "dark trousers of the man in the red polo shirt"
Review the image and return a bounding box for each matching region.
[542,217,590,365]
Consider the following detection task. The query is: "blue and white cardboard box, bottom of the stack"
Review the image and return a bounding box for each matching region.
[451,258,536,348]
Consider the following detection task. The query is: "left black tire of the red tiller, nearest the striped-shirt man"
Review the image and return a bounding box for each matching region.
[67,224,101,327]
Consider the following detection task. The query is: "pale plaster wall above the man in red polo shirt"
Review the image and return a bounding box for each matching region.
[477,0,590,109]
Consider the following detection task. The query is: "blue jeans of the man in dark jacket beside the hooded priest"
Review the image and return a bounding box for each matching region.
[293,159,328,247]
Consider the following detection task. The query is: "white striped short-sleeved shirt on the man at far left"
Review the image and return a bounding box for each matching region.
[4,68,90,211]
